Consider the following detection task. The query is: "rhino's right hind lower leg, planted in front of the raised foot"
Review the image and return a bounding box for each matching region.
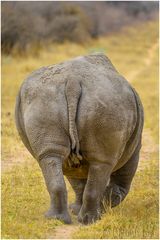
[78,162,113,224]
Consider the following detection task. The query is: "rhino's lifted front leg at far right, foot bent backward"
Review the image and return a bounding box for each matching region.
[103,143,140,207]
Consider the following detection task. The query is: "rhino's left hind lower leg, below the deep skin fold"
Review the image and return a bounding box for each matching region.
[39,157,71,224]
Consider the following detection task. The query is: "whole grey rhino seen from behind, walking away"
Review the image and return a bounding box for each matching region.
[15,54,143,224]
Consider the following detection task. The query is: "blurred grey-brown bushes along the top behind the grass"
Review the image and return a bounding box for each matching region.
[1,1,158,54]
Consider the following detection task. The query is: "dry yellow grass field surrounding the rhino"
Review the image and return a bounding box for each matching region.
[2,22,158,239]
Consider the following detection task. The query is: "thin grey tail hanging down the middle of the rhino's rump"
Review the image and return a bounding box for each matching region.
[65,78,82,163]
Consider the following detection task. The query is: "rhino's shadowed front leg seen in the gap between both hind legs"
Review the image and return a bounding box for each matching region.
[67,177,87,215]
